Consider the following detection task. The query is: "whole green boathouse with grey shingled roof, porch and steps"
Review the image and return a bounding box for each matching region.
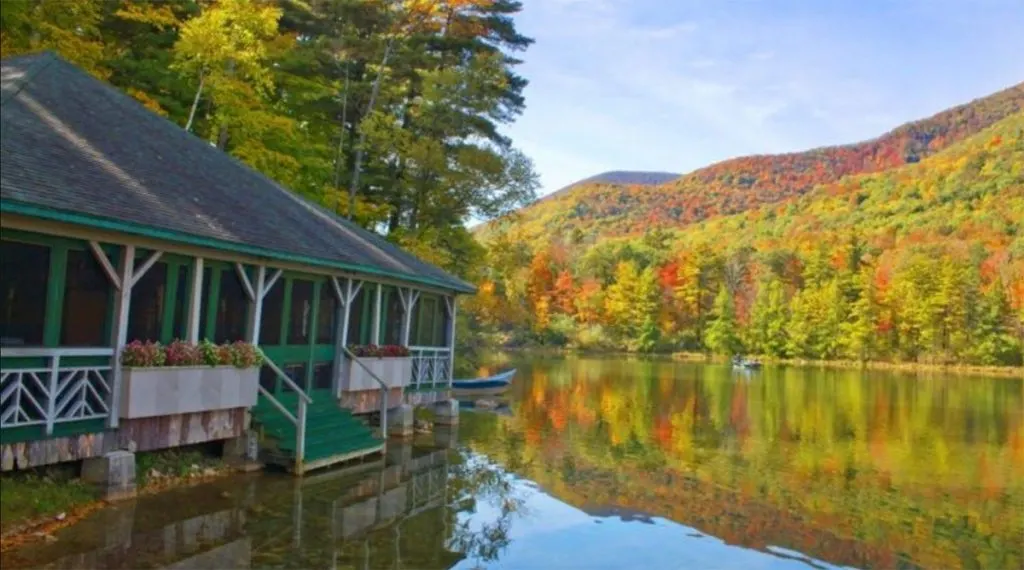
[0,53,474,473]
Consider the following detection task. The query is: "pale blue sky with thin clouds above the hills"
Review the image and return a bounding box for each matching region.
[506,0,1024,195]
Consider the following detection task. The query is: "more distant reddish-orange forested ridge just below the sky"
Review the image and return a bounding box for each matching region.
[478,84,1024,242]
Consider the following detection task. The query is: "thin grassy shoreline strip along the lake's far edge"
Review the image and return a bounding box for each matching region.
[497,347,1024,380]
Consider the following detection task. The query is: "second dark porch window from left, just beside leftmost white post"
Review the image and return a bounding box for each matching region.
[60,250,114,346]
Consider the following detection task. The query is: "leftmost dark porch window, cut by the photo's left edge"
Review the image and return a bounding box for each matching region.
[0,242,50,346]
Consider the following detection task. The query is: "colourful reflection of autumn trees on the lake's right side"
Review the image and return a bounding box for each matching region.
[473,360,1024,568]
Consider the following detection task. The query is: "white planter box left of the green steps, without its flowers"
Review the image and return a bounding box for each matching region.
[120,365,259,419]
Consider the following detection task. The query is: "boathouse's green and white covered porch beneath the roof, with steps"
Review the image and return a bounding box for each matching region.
[0,214,456,471]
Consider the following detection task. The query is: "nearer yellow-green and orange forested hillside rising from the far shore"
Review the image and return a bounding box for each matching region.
[473,113,1024,365]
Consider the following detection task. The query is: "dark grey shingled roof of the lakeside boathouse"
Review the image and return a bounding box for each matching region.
[0,52,474,293]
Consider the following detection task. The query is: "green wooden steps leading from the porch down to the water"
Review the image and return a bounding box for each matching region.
[252,392,384,474]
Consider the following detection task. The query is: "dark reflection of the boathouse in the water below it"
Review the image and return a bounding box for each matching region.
[2,431,507,570]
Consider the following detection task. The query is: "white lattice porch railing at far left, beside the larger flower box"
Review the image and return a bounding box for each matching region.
[0,348,114,435]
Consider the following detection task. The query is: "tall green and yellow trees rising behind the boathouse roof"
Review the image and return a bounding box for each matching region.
[0,0,537,278]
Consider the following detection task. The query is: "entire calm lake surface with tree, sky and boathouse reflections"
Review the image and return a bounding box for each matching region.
[0,359,1024,570]
